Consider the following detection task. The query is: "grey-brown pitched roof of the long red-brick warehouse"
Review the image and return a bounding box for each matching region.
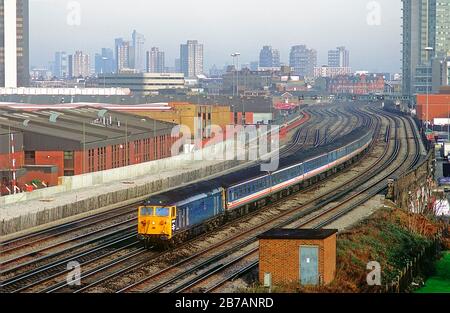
[0,107,174,150]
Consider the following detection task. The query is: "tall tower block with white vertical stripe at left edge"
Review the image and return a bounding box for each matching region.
[0,0,30,88]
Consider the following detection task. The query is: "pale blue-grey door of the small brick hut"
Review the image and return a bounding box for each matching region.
[300,246,319,286]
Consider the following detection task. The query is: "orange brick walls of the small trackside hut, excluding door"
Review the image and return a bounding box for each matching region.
[259,235,336,285]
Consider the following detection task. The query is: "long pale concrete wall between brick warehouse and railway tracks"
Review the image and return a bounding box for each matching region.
[0,114,284,236]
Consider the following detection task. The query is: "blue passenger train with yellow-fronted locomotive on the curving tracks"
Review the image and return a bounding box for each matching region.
[138,127,373,249]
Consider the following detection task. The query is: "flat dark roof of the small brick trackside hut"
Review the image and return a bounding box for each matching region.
[258,228,338,240]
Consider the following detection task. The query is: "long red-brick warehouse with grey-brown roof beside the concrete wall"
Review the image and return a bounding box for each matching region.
[0,107,176,195]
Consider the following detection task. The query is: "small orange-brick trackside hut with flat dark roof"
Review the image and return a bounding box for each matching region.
[258,228,337,285]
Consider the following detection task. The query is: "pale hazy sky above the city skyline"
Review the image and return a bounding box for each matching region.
[30,0,401,72]
